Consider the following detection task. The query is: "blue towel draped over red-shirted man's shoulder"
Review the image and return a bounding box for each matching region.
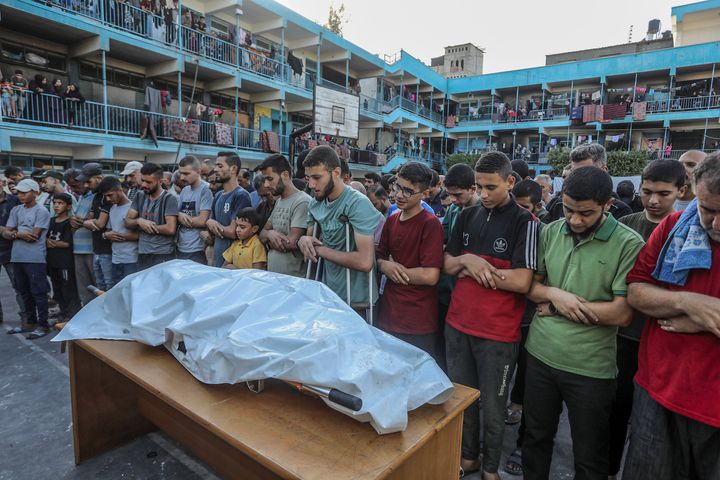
[652,199,712,287]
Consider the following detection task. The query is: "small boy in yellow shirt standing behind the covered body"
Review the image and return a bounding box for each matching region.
[223,207,267,270]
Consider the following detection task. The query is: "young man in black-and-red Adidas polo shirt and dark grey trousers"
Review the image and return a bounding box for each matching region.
[444,152,537,479]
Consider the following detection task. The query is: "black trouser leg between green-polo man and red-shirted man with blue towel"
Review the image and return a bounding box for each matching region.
[608,336,640,475]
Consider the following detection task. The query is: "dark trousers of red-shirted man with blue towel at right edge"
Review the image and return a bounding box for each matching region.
[623,384,720,480]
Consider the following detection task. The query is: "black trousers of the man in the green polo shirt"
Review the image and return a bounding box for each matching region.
[522,354,616,480]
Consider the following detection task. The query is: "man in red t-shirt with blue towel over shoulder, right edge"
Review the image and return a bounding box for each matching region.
[623,153,720,480]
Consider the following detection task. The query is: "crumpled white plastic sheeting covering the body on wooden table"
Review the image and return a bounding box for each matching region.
[53,260,453,434]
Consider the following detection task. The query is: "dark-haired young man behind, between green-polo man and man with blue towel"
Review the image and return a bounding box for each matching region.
[609,160,687,476]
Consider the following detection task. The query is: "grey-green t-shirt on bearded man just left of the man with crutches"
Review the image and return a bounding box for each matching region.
[268,192,310,277]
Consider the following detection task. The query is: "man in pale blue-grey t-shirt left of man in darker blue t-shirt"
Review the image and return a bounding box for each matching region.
[178,155,213,265]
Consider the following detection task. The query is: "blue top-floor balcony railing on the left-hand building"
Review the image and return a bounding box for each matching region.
[33,0,312,90]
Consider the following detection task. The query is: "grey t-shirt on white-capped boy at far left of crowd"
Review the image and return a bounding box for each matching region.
[7,203,50,263]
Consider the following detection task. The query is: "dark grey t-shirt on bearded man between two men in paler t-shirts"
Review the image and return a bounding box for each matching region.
[132,190,178,255]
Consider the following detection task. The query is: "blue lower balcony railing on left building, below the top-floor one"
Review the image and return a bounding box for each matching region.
[1,91,289,153]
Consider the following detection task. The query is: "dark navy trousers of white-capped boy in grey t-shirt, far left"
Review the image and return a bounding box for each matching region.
[13,263,49,327]
